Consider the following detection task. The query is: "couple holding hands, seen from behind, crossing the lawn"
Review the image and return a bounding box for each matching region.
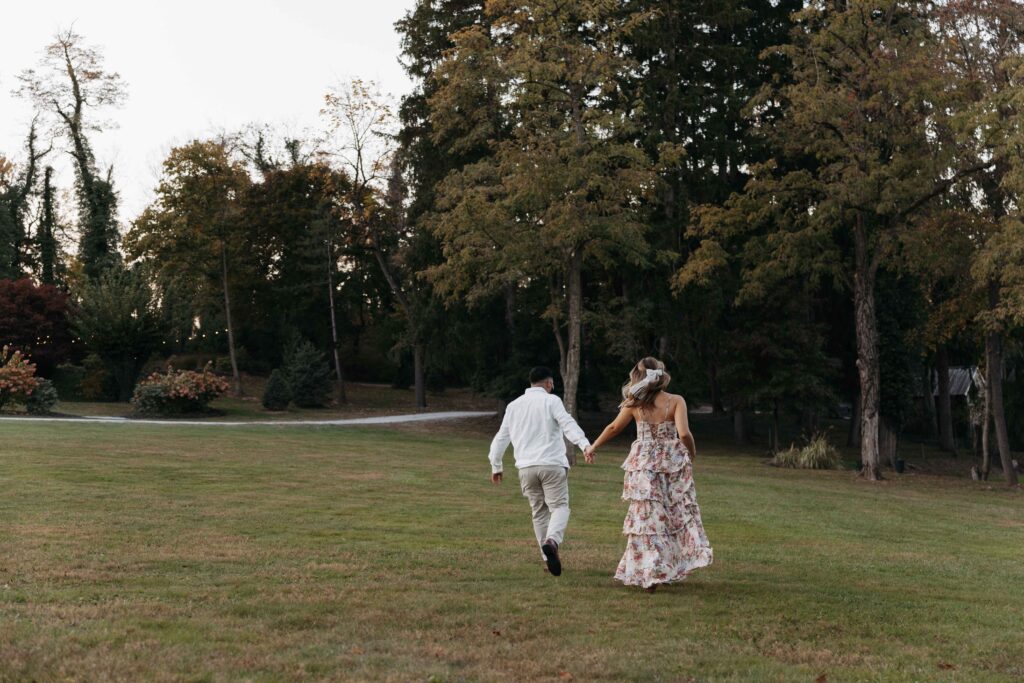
[489,357,712,593]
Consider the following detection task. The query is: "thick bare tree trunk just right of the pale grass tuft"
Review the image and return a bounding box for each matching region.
[853,215,882,481]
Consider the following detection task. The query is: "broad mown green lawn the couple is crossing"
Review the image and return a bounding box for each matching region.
[0,421,1024,681]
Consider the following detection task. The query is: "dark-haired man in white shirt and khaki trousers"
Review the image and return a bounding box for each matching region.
[489,368,590,577]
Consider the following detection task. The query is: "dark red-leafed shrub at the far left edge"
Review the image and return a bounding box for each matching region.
[0,279,73,377]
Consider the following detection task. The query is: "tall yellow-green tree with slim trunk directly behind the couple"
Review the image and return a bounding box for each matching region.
[430,0,670,414]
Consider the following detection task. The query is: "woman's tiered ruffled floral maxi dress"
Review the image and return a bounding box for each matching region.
[615,421,712,588]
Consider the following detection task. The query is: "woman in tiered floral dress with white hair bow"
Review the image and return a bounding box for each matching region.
[586,357,712,593]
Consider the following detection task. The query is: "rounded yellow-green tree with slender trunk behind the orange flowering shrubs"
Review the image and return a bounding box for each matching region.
[125,140,252,396]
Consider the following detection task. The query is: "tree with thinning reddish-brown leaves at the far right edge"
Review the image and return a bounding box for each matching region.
[937,0,1024,485]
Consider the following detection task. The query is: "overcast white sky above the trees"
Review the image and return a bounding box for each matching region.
[0,0,414,221]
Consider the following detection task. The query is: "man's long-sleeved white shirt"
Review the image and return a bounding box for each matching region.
[489,387,590,473]
